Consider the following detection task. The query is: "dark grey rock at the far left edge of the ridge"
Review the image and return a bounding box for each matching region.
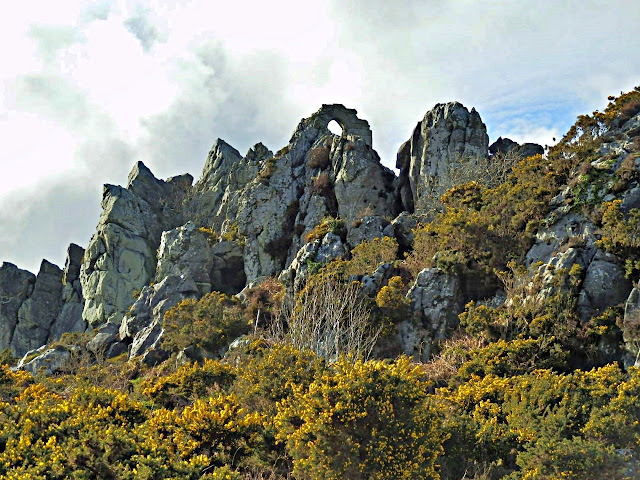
[0,262,36,353]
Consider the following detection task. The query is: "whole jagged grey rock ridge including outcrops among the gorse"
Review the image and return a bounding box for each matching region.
[0,95,640,368]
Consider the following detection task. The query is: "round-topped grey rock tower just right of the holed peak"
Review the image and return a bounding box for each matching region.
[396,102,489,213]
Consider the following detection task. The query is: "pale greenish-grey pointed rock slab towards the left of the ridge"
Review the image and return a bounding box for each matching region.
[80,162,190,327]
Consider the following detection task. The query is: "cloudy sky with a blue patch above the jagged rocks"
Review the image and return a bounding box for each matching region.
[0,0,640,273]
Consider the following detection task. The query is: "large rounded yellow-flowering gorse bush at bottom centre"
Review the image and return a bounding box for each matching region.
[275,358,442,479]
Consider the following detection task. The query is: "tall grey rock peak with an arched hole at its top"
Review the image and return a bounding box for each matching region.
[230,105,394,283]
